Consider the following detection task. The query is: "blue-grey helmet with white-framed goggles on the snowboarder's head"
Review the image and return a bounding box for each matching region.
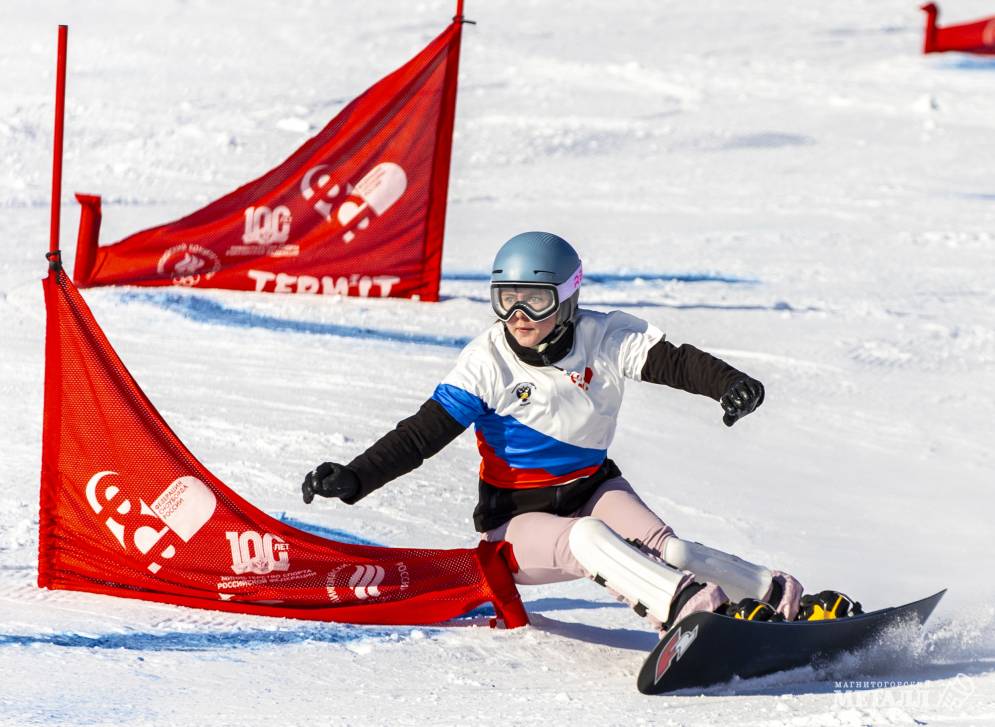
[491,232,584,325]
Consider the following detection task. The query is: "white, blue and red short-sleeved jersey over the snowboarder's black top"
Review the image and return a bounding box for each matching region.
[432,309,664,488]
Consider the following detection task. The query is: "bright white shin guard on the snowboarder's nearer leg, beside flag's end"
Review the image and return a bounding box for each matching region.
[570,517,687,622]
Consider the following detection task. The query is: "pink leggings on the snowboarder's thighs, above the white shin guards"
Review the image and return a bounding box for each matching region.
[481,477,674,586]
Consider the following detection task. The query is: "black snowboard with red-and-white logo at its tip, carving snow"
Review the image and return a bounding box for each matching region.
[637,590,946,694]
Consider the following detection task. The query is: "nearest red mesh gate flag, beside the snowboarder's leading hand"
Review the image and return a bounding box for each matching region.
[38,271,528,628]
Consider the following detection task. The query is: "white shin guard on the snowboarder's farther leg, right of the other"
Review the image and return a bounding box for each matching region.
[661,537,773,601]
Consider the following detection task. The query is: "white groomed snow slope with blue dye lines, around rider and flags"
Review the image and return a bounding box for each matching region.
[0,0,995,725]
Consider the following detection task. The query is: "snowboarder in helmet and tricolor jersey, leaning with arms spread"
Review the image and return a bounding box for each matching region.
[302,232,816,631]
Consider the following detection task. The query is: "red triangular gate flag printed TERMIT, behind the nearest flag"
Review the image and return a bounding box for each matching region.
[73,15,463,301]
